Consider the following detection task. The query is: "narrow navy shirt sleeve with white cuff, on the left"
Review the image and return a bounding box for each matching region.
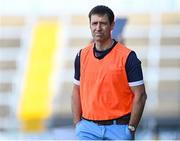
[73,50,81,85]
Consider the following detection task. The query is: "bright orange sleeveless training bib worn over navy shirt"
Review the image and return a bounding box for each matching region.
[80,43,134,120]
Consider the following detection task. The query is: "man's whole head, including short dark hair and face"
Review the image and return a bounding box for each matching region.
[89,5,114,44]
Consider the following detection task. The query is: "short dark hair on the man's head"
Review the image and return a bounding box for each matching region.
[88,5,114,24]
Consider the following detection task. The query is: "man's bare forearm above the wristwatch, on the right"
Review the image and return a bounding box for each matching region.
[129,84,147,128]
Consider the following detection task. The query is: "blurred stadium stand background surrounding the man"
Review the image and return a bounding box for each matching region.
[0,0,180,140]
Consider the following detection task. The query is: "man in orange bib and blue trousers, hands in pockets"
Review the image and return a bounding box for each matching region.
[72,5,147,140]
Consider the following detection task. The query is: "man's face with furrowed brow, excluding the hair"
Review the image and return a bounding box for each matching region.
[90,14,114,42]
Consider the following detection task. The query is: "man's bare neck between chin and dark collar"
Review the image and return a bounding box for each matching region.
[95,39,113,51]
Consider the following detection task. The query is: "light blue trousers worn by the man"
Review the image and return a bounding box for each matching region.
[76,119,134,140]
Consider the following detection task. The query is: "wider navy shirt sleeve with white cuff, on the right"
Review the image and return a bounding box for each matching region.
[125,51,144,86]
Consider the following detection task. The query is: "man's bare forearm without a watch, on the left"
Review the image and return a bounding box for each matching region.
[71,84,82,125]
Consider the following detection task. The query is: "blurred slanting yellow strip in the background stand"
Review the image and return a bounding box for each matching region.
[18,21,58,131]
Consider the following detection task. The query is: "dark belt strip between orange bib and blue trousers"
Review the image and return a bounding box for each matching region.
[82,113,131,125]
